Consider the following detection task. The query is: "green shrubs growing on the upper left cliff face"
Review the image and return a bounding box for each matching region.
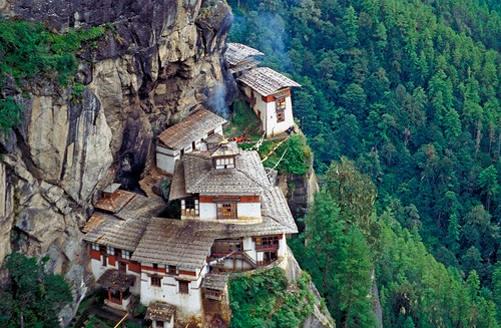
[0,18,105,131]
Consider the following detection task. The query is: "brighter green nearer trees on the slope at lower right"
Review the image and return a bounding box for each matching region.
[291,159,500,328]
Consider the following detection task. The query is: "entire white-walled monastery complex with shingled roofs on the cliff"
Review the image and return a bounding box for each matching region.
[84,43,299,327]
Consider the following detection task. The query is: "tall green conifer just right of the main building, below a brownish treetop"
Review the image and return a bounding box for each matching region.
[291,188,374,327]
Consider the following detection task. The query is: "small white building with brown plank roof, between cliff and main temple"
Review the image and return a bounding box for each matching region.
[156,108,226,174]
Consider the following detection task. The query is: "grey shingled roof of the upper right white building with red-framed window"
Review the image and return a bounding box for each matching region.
[237,67,301,96]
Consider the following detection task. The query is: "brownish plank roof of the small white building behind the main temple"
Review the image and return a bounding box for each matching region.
[158,108,226,150]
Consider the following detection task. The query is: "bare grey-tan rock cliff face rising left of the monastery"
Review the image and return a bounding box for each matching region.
[0,0,231,318]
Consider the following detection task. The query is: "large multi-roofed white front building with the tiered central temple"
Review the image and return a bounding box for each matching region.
[84,141,297,327]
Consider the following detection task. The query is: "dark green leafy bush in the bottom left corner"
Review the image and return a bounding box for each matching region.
[0,253,72,328]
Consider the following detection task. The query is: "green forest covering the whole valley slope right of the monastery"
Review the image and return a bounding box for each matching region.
[229,0,501,327]
